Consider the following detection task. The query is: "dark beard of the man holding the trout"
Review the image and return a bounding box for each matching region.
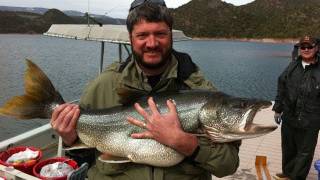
[132,46,172,69]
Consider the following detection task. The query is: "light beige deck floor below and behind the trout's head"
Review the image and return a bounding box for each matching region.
[213,107,320,180]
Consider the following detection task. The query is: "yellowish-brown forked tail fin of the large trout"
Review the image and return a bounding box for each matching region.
[0,59,65,119]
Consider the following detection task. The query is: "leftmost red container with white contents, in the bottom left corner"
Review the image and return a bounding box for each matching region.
[0,146,42,175]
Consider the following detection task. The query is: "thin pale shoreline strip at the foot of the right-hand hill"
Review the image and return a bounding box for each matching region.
[192,37,299,44]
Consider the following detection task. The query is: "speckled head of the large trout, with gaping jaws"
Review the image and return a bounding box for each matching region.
[199,93,277,142]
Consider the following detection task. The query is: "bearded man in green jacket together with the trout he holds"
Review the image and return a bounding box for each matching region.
[0,0,277,180]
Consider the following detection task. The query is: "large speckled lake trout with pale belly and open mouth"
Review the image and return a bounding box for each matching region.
[0,60,277,167]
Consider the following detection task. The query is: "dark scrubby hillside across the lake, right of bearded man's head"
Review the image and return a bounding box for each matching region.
[172,0,320,38]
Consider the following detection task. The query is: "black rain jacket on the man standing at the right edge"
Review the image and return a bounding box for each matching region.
[273,57,320,129]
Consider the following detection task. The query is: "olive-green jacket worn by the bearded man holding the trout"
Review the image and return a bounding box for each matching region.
[80,56,239,180]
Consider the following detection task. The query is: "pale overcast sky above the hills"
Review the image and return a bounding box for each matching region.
[0,0,254,18]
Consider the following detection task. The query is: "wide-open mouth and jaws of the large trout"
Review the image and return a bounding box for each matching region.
[242,101,278,135]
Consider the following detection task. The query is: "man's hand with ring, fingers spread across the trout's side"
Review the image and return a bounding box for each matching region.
[128,97,198,156]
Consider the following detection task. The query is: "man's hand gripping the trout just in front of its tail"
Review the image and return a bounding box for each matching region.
[50,103,80,145]
